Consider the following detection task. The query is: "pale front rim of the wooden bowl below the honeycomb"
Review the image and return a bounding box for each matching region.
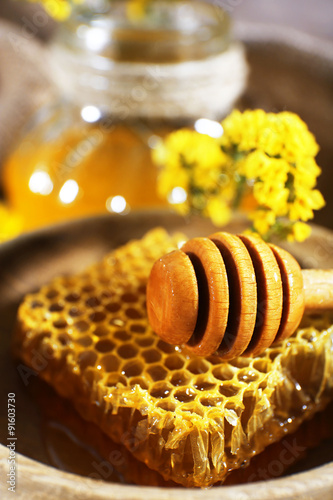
[0,447,333,500]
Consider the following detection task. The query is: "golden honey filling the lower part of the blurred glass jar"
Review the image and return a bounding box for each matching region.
[3,124,165,230]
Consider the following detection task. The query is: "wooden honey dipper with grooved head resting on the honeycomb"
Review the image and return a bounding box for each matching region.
[147,233,333,360]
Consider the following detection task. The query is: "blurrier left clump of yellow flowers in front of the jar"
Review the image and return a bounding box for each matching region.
[153,129,236,225]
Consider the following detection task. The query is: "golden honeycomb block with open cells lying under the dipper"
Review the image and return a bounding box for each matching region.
[15,229,333,487]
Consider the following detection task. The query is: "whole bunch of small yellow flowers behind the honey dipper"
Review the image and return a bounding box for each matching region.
[153,110,325,241]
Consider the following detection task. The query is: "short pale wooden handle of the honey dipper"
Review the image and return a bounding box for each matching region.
[302,269,333,310]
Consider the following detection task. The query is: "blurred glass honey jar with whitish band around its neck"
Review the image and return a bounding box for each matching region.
[3,0,247,230]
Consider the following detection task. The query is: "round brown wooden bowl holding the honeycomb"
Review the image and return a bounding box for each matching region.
[0,212,333,500]
